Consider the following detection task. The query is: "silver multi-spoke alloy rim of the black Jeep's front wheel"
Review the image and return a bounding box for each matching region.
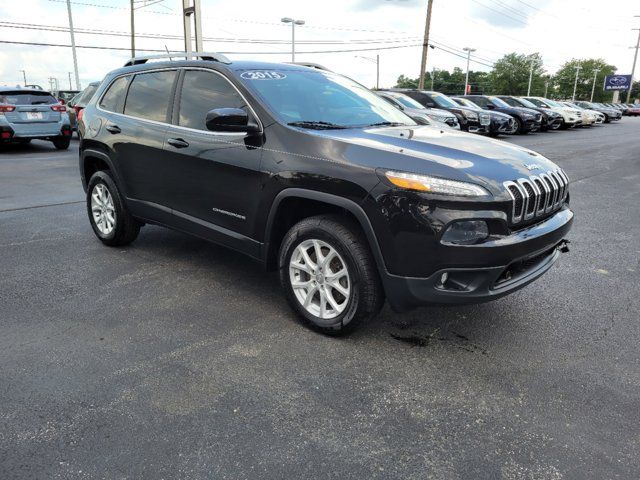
[289,239,351,320]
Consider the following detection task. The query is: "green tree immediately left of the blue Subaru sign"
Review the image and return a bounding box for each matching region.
[553,58,626,102]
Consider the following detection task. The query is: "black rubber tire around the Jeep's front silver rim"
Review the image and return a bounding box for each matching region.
[278,215,385,335]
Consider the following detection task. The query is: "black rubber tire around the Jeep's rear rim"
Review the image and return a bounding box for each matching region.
[87,170,141,247]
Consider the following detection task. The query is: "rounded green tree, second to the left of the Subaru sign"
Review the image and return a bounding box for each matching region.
[488,52,544,95]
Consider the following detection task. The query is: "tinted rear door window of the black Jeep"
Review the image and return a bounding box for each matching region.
[124,70,176,122]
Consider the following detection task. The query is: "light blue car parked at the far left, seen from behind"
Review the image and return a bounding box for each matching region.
[0,87,71,150]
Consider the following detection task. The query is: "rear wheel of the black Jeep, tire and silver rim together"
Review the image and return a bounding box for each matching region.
[87,171,141,246]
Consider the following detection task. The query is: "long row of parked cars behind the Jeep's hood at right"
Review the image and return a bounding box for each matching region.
[376,88,640,137]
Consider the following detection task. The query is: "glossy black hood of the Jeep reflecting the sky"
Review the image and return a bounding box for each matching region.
[307,126,558,195]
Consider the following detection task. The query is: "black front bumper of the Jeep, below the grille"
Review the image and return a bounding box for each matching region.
[382,207,573,311]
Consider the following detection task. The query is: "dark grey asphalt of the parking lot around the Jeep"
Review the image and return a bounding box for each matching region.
[0,122,640,479]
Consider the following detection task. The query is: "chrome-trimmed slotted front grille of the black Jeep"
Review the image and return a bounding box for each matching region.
[504,169,569,224]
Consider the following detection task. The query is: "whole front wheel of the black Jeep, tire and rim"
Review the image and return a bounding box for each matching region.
[278,215,384,335]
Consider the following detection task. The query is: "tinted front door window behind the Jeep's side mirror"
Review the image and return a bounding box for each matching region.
[178,70,247,130]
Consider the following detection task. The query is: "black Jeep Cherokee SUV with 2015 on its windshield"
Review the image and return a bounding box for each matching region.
[79,54,573,333]
